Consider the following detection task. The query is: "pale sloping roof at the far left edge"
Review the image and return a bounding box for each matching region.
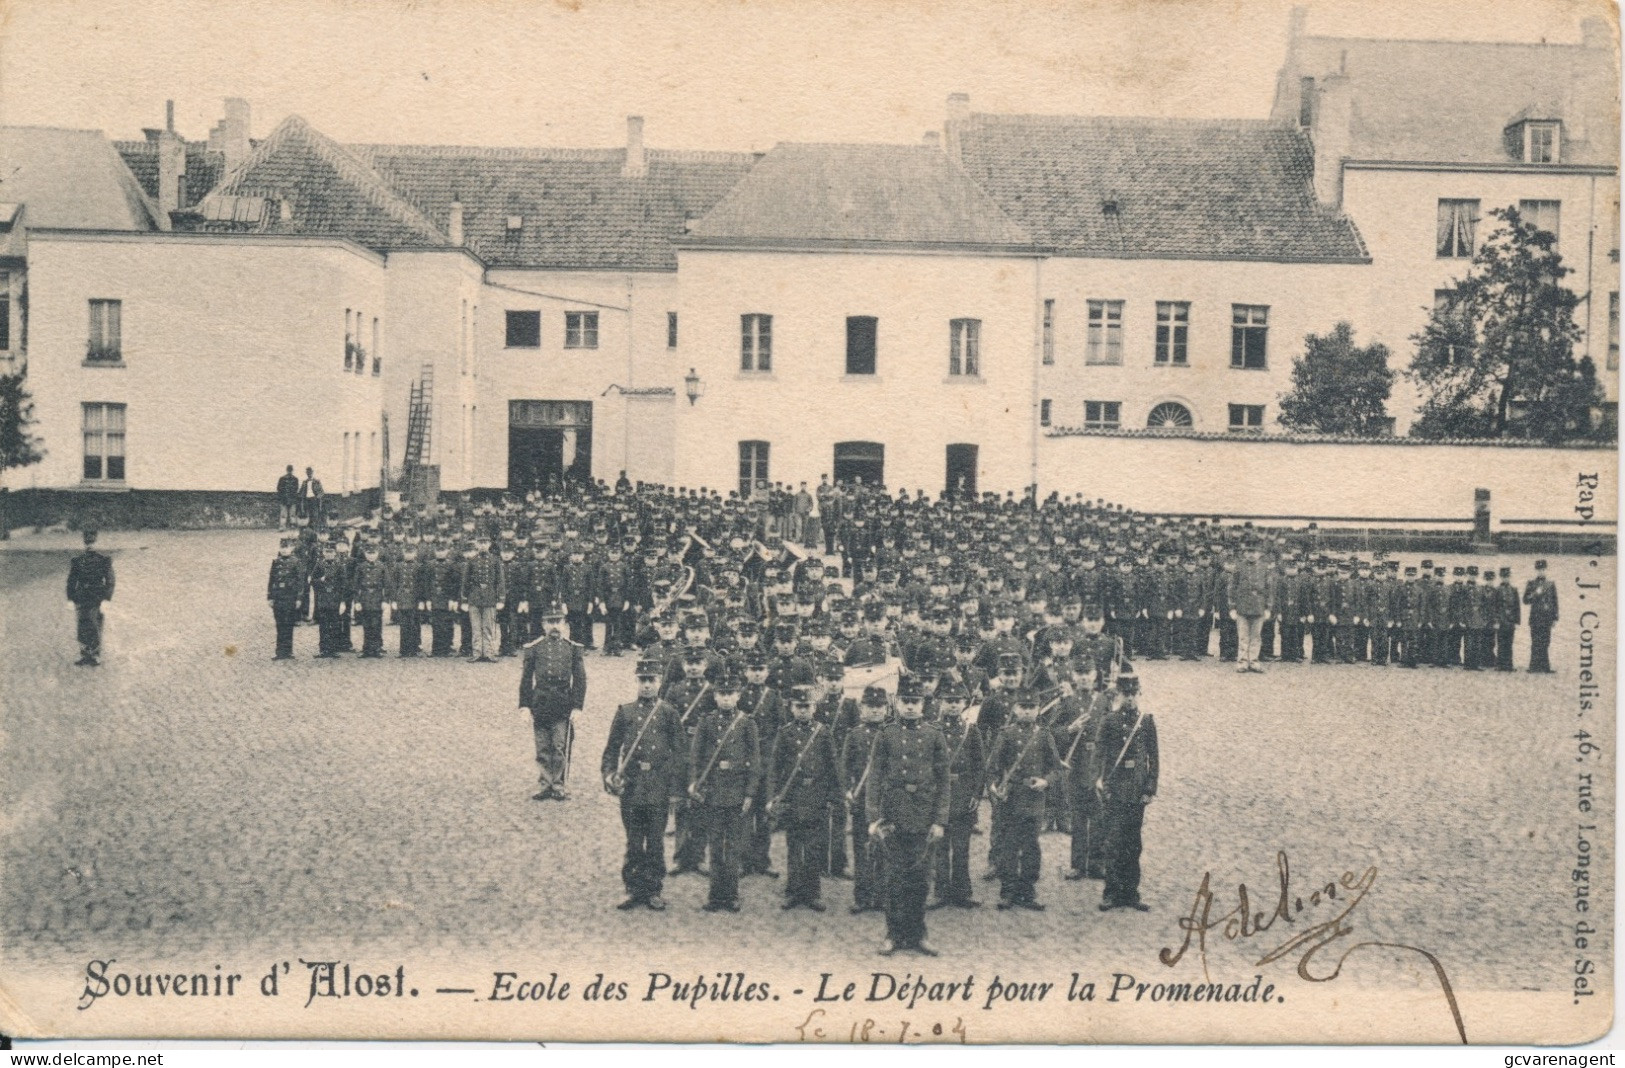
[0,127,158,231]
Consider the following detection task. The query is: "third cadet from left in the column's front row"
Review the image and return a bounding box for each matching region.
[767,686,840,912]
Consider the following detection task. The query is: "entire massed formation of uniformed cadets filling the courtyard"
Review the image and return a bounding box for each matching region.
[256,486,1557,953]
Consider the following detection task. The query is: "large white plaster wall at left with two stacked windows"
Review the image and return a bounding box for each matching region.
[22,234,385,493]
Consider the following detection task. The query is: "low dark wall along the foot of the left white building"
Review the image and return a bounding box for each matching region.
[0,489,379,532]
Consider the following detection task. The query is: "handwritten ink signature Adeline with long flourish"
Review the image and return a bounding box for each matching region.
[1157,850,1467,1044]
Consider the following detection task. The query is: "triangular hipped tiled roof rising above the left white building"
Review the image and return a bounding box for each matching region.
[187,115,450,250]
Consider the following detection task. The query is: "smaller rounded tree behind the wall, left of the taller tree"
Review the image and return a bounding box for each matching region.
[1277,322,1394,437]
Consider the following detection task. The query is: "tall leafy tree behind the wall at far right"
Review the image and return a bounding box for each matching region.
[1406,208,1602,442]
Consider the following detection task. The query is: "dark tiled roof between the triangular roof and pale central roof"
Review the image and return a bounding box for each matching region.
[351,145,759,270]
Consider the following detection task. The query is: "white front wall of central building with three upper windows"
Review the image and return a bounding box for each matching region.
[674,250,1038,493]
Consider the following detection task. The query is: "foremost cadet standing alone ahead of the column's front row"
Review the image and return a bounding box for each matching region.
[866,676,951,957]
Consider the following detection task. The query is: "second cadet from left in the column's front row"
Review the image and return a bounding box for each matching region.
[685,676,762,912]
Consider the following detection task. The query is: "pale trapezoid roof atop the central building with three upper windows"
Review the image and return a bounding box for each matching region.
[689,145,1032,247]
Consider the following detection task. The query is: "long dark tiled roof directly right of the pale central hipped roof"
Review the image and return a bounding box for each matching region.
[949,115,1367,262]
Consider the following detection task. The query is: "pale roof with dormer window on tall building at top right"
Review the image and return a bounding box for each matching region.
[1284,37,1620,167]
